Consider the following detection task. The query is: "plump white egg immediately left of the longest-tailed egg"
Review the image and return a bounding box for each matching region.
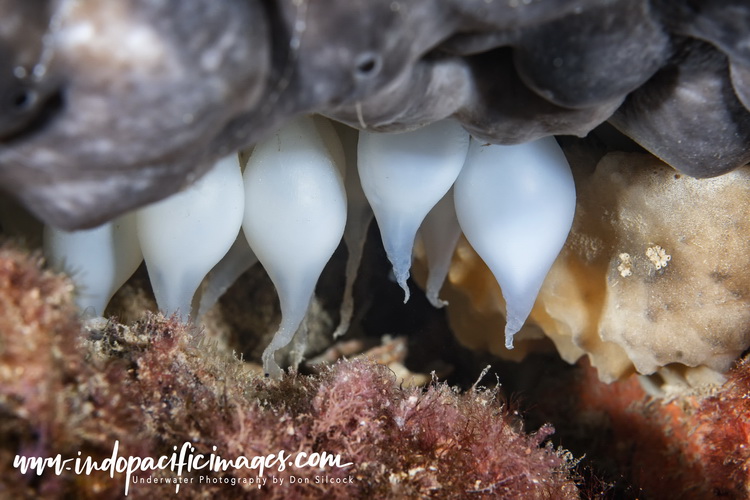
[136,154,245,321]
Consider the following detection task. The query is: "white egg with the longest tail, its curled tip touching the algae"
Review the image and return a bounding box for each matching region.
[242,117,346,377]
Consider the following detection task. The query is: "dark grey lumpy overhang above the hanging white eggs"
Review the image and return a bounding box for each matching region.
[0,0,750,229]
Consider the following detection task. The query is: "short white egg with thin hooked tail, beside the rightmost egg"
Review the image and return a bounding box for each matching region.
[357,120,469,302]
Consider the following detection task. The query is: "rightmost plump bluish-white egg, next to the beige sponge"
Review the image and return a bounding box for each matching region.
[454,137,576,349]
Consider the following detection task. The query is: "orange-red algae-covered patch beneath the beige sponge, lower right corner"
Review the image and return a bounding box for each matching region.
[532,358,750,500]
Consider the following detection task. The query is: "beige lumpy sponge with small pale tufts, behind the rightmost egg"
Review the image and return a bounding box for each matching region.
[434,153,750,381]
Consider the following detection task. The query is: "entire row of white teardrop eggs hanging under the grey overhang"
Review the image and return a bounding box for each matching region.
[45,116,575,376]
